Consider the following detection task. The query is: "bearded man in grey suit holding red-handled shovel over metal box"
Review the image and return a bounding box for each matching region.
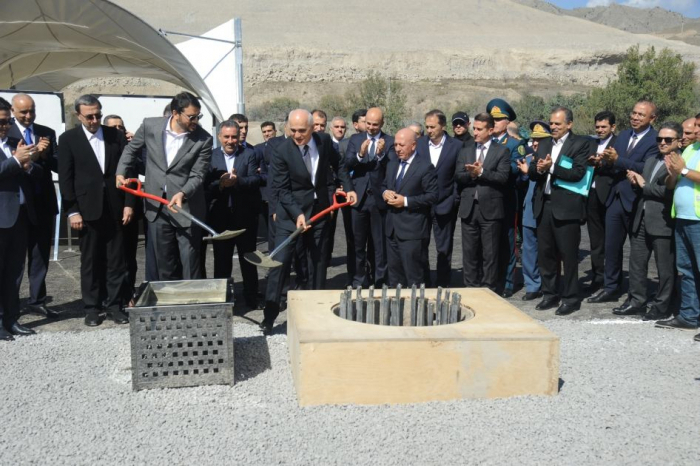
[117,92,212,280]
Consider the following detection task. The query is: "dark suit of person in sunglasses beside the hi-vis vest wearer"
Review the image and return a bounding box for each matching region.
[629,154,676,315]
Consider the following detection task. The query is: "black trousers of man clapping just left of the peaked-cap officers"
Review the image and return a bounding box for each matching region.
[462,201,500,291]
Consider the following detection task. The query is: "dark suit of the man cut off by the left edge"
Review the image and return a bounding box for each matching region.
[0,138,44,331]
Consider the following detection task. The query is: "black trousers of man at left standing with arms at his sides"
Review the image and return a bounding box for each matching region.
[80,206,132,310]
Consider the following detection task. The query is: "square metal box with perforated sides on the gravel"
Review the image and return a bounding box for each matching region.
[129,280,234,390]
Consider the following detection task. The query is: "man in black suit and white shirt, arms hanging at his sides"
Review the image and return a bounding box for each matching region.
[58,95,136,327]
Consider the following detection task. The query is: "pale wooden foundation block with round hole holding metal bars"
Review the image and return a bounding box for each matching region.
[287,288,559,406]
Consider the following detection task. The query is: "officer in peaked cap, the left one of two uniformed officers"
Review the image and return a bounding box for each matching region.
[486,99,525,298]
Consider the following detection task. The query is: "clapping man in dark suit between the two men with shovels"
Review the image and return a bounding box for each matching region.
[205,120,260,309]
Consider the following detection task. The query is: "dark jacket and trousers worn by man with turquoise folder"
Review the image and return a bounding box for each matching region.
[528,132,592,304]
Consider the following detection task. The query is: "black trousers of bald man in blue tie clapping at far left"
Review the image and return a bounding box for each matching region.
[22,215,54,305]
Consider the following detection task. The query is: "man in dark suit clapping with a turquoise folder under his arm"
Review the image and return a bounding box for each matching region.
[528,107,591,316]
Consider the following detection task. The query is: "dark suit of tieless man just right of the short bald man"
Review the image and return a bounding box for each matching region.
[416,135,463,287]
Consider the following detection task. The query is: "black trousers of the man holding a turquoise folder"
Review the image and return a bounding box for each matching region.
[537,200,581,304]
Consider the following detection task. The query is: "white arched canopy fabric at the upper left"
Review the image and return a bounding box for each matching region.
[0,0,223,121]
